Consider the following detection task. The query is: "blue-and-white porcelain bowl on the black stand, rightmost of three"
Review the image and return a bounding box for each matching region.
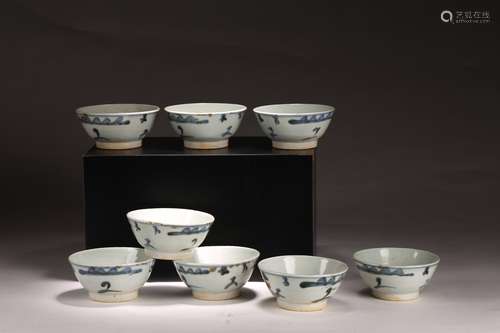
[253,104,335,149]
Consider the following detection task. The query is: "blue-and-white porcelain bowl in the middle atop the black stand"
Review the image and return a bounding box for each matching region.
[165,103,247,149]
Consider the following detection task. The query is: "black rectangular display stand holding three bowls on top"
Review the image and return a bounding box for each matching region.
[83,137,316,280]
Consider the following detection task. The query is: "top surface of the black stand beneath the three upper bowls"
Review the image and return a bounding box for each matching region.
[84,137,315,157]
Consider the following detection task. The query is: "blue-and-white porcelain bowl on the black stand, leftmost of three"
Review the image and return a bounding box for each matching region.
[76,104,160,149]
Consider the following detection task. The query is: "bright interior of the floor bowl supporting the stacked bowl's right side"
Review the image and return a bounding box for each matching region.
[177,246,260,266]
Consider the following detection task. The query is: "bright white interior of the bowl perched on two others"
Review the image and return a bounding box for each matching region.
[127,208,215,226]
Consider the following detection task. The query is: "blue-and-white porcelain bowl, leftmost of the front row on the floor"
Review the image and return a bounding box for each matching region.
[68,247,155,303]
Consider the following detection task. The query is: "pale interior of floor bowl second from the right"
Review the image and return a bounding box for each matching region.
[259,256,347,276]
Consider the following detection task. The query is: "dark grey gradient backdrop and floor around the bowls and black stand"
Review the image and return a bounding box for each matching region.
[0,0,500,332]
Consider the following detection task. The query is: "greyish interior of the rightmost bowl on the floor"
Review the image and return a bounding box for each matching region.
[354,248,439,267]
